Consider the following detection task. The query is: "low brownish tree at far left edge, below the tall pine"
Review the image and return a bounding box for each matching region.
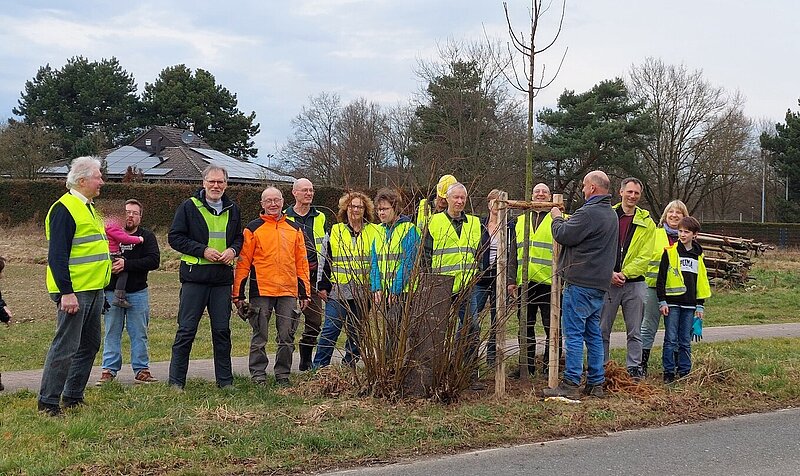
[0,121,59,180]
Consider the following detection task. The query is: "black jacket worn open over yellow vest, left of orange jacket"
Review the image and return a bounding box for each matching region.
[168,188,244,286]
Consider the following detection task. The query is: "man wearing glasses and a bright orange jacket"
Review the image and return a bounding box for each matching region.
[232,187,311,387]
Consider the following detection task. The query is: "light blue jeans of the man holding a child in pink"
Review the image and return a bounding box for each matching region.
[103,288,150,375]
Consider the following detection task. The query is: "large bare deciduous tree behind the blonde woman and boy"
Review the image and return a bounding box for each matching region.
[629,58,750,216]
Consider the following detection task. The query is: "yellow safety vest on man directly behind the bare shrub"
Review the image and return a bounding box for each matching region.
[428,213,481,293]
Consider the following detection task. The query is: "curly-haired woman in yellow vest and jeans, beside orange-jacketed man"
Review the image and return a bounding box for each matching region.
[311,192,379,369]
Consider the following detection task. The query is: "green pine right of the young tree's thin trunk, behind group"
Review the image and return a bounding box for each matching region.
[537,78,652,205]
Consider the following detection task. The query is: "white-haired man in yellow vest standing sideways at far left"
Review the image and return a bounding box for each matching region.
[38,157,111,416]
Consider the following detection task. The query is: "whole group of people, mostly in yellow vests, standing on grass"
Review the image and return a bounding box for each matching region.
[29,157,710,415]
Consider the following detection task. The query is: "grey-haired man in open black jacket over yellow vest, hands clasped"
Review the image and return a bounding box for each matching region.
[168,165,242,389]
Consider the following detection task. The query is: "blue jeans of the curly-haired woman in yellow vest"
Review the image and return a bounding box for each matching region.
[311,299,362,369]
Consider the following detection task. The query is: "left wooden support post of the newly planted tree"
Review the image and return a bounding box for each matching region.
[493,191,508,398]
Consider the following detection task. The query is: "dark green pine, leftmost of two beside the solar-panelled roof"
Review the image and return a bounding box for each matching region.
[13,56,139,157]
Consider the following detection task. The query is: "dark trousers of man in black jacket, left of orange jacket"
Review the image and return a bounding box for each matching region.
[169,283,233,387]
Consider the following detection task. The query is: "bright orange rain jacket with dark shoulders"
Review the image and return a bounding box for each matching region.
[232,214,311,300]
